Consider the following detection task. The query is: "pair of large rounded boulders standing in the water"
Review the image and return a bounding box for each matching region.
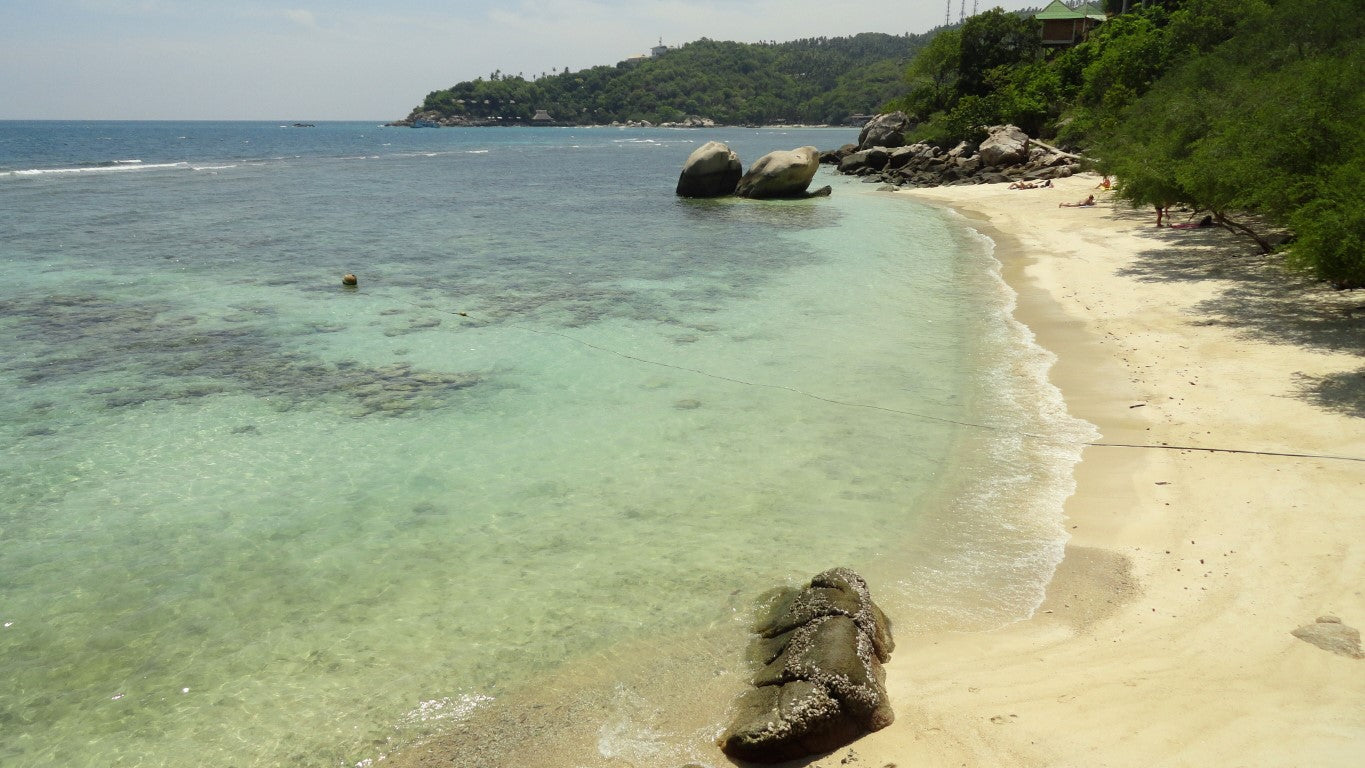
[676,142,830,198]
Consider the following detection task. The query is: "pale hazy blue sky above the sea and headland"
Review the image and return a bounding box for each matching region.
[0,0,1047,120]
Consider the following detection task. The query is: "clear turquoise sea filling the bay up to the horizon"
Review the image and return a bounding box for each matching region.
[0,121,1093,768]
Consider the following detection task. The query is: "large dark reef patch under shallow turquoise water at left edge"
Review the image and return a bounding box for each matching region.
[0,295,485,417]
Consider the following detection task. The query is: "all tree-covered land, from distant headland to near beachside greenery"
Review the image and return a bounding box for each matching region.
[397,0,1365,288]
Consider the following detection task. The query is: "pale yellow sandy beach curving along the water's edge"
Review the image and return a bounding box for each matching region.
[379,176,1365,768]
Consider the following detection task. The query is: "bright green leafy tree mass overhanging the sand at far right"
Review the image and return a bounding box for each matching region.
[1099,0,1365,288]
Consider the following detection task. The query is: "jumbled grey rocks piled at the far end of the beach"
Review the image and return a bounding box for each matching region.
[820,112,1081,187]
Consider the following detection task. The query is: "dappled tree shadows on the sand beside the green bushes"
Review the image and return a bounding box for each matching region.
[1110,210,1365,419]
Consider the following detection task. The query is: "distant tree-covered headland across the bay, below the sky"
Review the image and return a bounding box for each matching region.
[398,33,932,124]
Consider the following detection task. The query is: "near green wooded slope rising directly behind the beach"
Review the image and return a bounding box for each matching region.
[894,0,1365,288]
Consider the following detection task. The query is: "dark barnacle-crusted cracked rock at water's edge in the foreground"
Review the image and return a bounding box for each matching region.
[719,567,895,763]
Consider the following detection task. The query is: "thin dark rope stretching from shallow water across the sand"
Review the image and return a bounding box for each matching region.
[390,297,1365,462]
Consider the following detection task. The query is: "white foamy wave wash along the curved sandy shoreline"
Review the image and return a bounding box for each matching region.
[898,211,1099,629]
